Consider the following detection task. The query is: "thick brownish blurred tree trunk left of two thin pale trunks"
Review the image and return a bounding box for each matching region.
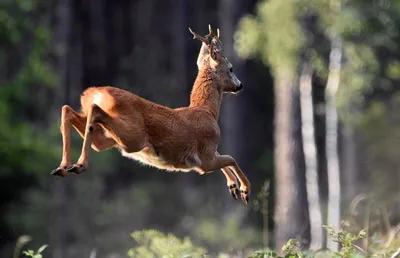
[275,75,309,249]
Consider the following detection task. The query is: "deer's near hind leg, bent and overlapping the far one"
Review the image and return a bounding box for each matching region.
[67,104,145,174]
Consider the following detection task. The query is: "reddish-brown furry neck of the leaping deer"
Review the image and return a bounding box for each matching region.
[189,68,223,120]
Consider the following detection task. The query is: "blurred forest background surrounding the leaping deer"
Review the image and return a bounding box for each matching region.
[0,0,400,258]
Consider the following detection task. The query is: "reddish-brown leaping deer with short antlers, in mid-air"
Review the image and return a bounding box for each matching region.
[51,25,250,204]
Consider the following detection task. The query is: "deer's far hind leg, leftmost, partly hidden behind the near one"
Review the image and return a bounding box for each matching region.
[50,105,115,177]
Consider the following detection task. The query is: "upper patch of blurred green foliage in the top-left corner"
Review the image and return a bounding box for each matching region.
[0,0,57,87]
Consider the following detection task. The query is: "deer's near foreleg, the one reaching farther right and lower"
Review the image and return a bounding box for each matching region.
[201,152,251,204]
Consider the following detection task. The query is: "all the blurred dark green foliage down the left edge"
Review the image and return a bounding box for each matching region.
[0,0,57,176]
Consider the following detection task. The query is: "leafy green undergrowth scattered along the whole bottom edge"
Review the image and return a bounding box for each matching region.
[14,226,400,258]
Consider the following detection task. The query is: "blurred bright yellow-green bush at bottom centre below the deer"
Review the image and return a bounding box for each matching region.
[128,229,206,258]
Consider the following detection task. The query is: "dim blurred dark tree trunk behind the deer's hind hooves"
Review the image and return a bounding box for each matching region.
[49,0,72,258]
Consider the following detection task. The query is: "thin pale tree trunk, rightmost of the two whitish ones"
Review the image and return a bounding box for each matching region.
[325,36,342,251]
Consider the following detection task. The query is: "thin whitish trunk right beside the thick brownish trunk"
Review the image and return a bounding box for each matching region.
[300,61,323,250]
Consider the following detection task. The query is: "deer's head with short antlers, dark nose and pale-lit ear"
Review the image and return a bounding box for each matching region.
[189,25,243,93]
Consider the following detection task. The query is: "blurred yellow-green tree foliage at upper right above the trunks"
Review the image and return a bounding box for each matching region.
[235,0,400,125]
